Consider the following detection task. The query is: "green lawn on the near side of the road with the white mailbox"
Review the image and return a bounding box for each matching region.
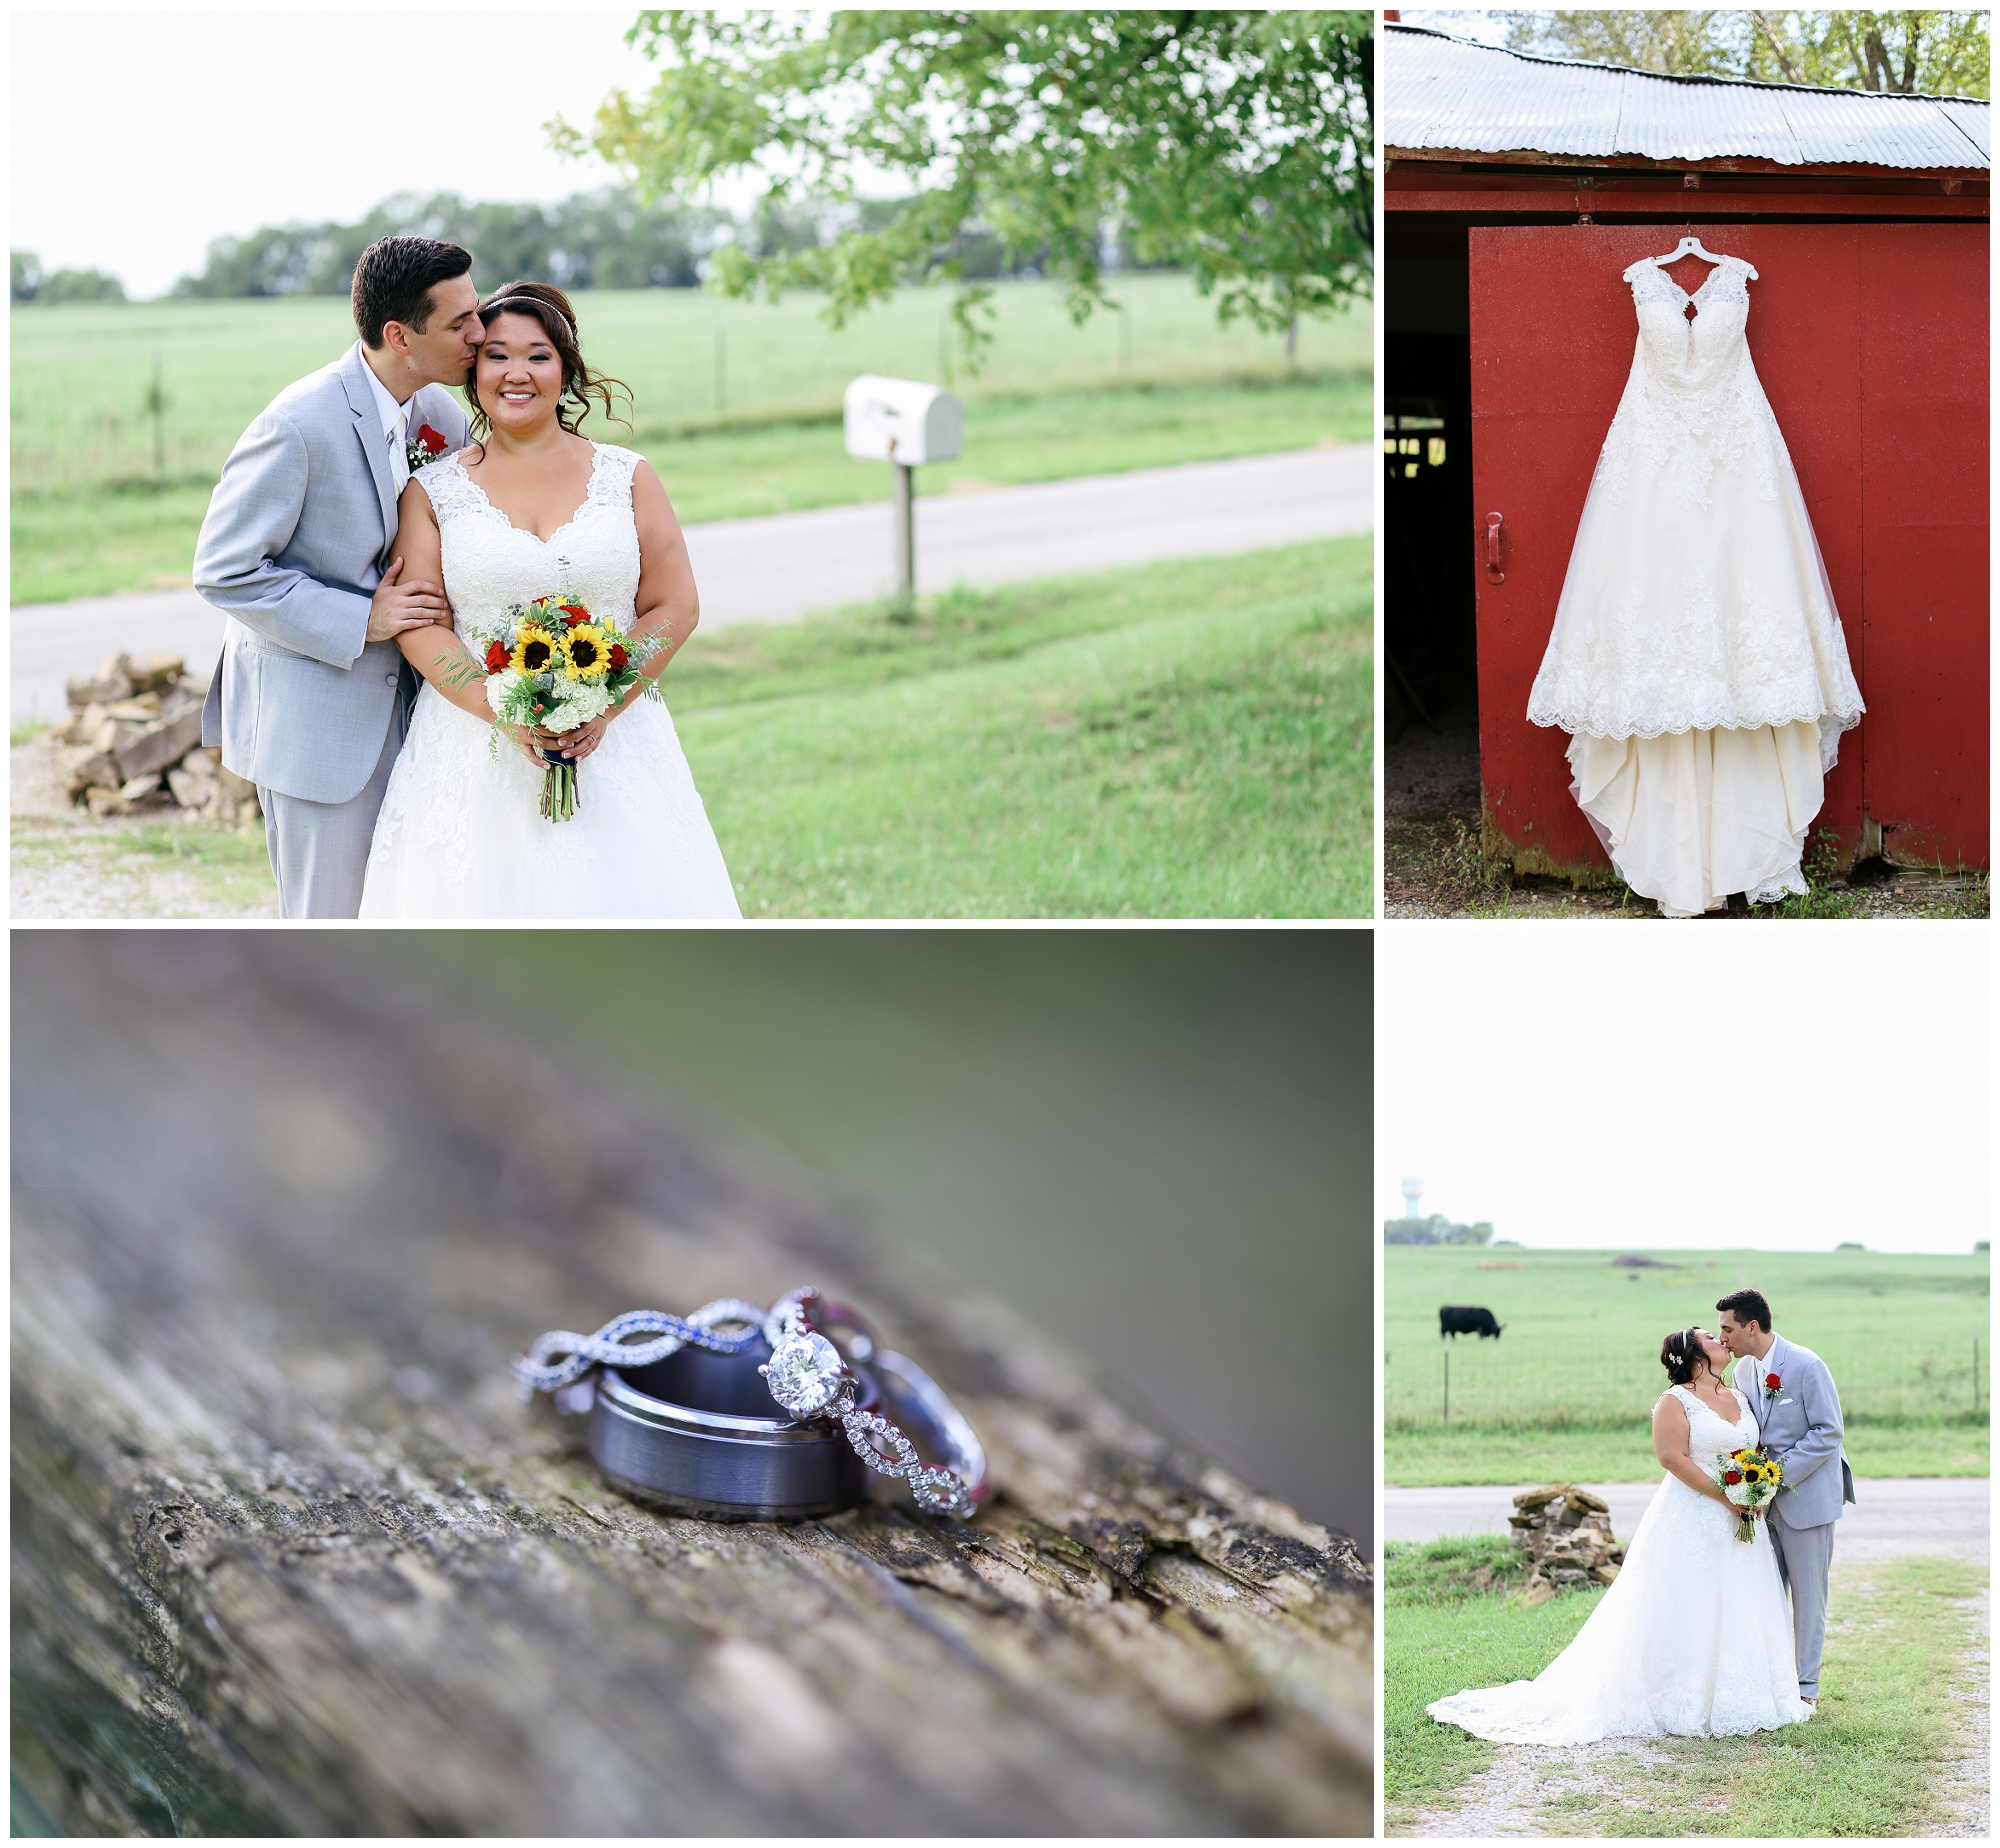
[14,538,1374,918]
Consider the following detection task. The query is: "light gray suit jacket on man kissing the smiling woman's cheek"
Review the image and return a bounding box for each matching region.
[194,340,466,802]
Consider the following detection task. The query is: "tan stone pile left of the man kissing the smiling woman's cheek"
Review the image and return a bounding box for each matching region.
[56,652,258,826]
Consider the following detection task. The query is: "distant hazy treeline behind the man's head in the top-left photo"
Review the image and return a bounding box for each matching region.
[14,186,1160,302]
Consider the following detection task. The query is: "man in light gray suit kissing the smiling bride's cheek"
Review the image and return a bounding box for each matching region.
[194,238,482,918]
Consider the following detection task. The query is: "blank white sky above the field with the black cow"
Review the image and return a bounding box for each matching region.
[1376,922,1988,1252]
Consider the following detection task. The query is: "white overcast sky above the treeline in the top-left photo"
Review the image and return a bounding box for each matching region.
[10,0,776,296]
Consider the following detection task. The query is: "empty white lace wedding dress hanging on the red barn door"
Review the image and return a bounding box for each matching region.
[1528,256,1864,916]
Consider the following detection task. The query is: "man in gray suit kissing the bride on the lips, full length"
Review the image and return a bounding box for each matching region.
[1716,1290,1854,1704]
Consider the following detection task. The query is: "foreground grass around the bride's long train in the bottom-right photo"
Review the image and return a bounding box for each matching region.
[1382,1536,1986,1840]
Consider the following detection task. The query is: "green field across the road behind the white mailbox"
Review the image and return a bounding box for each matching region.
[10,276,1372,604]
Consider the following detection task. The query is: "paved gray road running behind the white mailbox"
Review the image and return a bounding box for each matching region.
[10,444,1376,720]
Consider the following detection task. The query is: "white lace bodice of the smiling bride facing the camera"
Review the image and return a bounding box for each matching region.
[418,442,640,632]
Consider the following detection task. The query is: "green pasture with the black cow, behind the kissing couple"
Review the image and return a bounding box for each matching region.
[1382,1246,1990,1486]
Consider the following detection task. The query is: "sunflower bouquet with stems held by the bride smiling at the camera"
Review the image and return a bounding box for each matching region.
[466,592,662,822]
